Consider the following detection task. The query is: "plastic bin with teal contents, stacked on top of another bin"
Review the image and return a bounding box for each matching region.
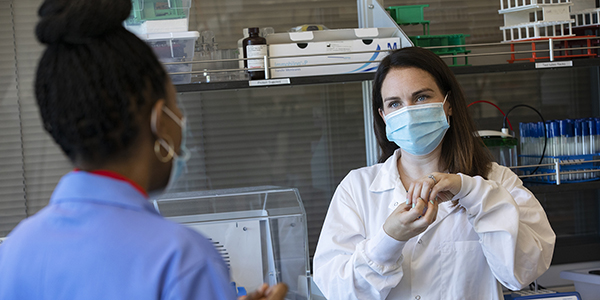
[124,0,192,34]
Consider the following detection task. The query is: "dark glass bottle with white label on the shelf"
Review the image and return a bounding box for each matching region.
[242,27,267,80]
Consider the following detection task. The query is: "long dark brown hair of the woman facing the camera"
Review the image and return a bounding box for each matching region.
[373,47,493,177]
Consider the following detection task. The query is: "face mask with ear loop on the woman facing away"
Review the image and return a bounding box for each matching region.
[152,106,190,195]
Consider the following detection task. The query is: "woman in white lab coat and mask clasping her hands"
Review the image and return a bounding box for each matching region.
[313,47,556,300]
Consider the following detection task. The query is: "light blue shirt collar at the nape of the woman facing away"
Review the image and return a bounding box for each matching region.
[50,171,158,214]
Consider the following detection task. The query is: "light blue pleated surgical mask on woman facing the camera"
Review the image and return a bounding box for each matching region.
[385,94,450,155]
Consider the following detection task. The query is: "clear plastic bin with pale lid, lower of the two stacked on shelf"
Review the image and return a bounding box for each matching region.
[138,31,200,84]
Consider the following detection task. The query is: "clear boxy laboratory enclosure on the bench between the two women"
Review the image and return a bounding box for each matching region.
[153,186,311,299]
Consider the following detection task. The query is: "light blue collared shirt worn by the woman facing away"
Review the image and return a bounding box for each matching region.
[0,171,236,300]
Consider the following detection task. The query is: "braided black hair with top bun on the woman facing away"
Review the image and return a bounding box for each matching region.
[35,0,167,163]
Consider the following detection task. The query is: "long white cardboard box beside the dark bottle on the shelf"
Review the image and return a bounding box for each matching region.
[266,28,412,78]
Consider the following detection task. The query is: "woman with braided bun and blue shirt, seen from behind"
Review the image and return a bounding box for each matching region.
[0,0,287,300]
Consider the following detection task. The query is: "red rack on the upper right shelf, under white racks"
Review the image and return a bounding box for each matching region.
[507,35,600,64]
